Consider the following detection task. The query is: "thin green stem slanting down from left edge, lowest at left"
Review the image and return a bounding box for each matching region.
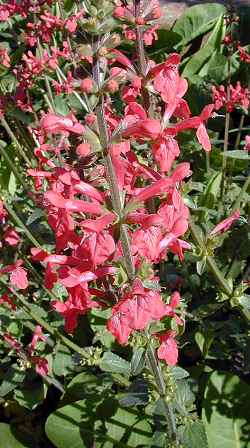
[0,279,89,358]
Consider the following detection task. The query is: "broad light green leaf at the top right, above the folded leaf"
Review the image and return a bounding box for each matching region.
[173,3,226,45]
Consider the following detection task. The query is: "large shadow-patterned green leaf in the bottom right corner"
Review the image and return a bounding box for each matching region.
[202,371,250,448]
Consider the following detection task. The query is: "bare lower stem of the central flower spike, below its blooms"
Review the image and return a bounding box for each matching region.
[147,342,178,446]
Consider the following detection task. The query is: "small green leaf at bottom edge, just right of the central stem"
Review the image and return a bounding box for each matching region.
[183,422,209,448]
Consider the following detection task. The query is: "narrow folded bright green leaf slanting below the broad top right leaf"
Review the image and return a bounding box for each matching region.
[182,15,226,77]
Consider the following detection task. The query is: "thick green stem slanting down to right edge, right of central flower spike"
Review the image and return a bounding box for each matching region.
[189,219,233,297]
